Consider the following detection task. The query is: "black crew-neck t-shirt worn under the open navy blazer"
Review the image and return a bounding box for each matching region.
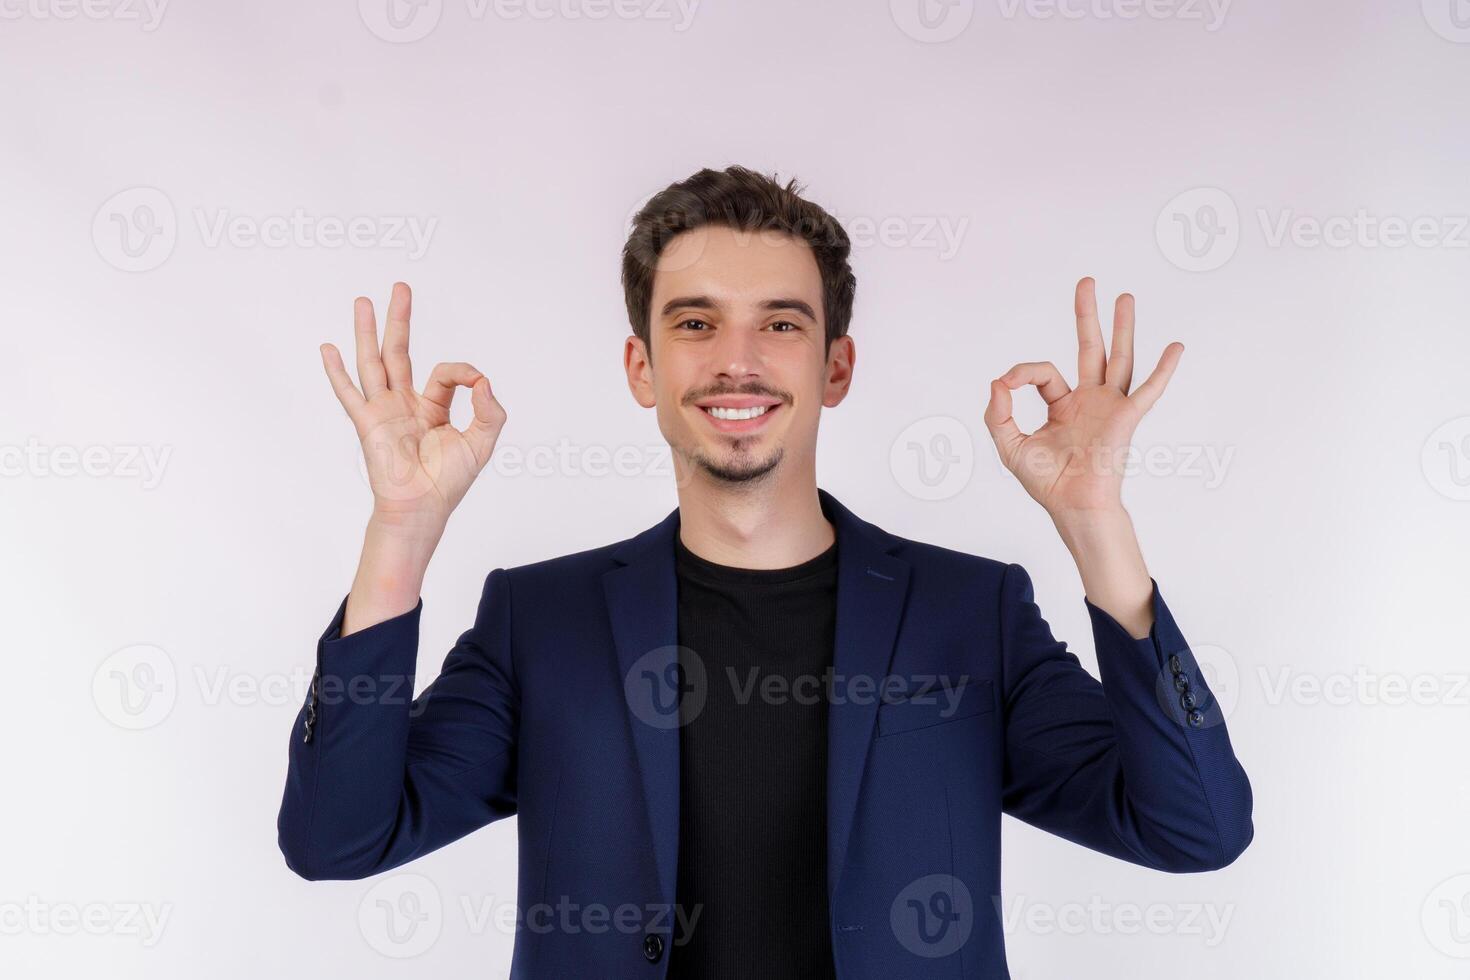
[669,535,836,980]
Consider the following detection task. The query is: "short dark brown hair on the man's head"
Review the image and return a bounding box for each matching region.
[623,166,857,360]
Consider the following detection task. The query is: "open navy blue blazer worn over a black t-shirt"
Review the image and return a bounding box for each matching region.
[278,489,1252,980]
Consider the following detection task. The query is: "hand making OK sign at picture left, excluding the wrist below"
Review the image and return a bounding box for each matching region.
[322,282,506,531]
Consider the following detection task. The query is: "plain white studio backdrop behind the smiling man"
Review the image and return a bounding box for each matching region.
[0,0,1470,980]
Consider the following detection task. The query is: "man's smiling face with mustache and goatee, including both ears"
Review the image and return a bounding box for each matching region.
[623,225,854,483]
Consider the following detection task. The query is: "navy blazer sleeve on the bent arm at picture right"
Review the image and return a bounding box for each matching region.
[1000,564,1254,873]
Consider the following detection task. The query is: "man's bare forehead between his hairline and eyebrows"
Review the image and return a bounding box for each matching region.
[650,225,822,310]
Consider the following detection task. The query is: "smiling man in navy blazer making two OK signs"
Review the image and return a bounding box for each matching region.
[279,167,1252,980]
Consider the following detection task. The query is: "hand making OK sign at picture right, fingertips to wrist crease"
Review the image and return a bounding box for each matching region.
[985,278,1185,519]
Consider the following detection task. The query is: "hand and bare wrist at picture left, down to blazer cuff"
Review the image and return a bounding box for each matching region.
[322,282,506,636]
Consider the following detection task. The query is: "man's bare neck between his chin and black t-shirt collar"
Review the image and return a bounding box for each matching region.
[679,470,836,569]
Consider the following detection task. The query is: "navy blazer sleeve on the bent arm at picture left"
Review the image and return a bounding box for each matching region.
[276,569,519,880]
